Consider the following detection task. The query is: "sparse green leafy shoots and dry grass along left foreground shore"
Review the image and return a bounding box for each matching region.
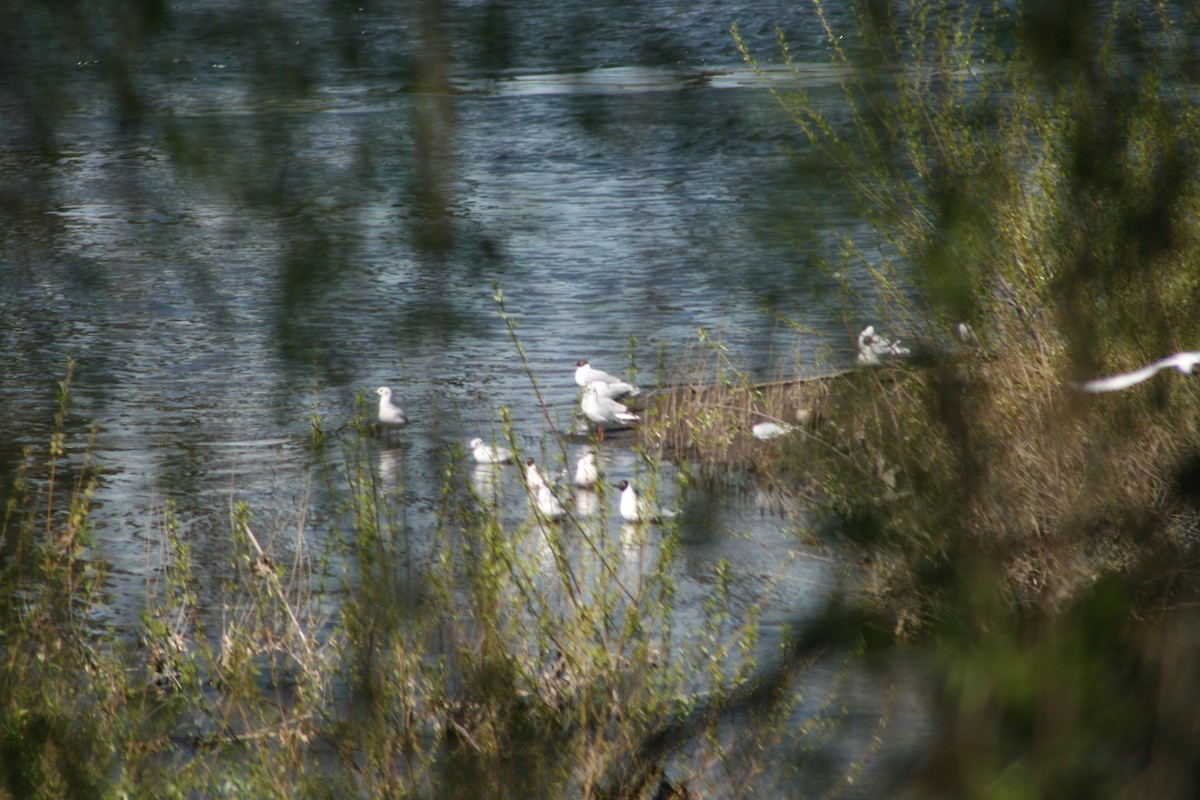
[0,357,864,798]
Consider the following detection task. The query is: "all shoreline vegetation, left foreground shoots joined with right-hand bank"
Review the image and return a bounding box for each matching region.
[7,1,1200,799]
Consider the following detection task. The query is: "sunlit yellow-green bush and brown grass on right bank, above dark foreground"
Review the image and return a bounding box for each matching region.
[720,2,1200,616]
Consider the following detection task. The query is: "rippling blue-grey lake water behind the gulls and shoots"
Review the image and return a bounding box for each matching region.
[0,1,931,796]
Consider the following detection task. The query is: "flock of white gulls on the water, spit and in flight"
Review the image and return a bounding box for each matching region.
[376,323,1200,523]
